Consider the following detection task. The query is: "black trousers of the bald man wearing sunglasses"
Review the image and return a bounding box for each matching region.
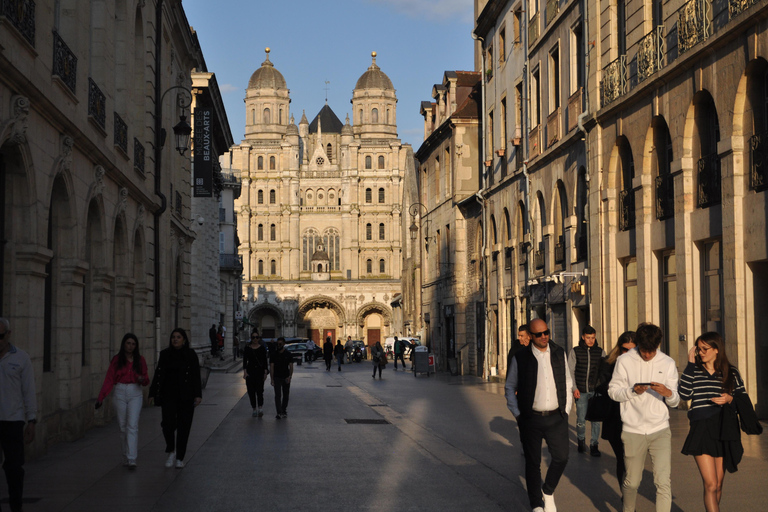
[517,413,569,508]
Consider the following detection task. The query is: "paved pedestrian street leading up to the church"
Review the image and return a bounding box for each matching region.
[13,362,768,512]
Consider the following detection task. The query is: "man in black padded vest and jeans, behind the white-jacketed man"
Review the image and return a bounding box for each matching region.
[568,325,605,457]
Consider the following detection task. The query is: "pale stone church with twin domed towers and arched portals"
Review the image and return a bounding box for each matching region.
[223,48,413,344]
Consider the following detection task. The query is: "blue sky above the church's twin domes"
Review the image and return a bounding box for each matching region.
[183,0,474,151]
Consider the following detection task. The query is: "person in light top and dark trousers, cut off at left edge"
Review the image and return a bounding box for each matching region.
[0,317,37,512]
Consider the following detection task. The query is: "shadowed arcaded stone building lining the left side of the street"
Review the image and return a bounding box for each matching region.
[0,0,226,453]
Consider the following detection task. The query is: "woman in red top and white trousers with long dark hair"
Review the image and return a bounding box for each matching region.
[94,332,149,469]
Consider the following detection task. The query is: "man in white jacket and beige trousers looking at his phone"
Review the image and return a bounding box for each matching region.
[608,324,680,512]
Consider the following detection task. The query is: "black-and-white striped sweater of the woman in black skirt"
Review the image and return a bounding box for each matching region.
[677,362,745,421]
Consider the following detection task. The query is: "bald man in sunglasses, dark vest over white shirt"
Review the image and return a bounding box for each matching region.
[504,318,573,512]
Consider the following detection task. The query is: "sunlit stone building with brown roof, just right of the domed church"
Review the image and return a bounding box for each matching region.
[414,71,485,375]
